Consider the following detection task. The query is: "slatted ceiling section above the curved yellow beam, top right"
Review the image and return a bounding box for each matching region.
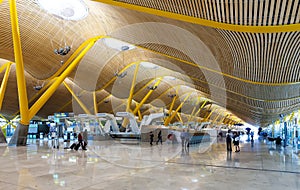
[117,0,299,26]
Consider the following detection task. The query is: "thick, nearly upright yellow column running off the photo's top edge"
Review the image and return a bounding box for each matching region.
[9,0,30,125]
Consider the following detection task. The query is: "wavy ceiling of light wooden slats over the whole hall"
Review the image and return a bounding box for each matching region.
[0,0,300,125]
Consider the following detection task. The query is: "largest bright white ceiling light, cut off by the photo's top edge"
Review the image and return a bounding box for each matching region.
[37,0,88,20]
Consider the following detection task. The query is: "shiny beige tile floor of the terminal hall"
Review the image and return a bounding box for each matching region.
[0,136,300,190]
